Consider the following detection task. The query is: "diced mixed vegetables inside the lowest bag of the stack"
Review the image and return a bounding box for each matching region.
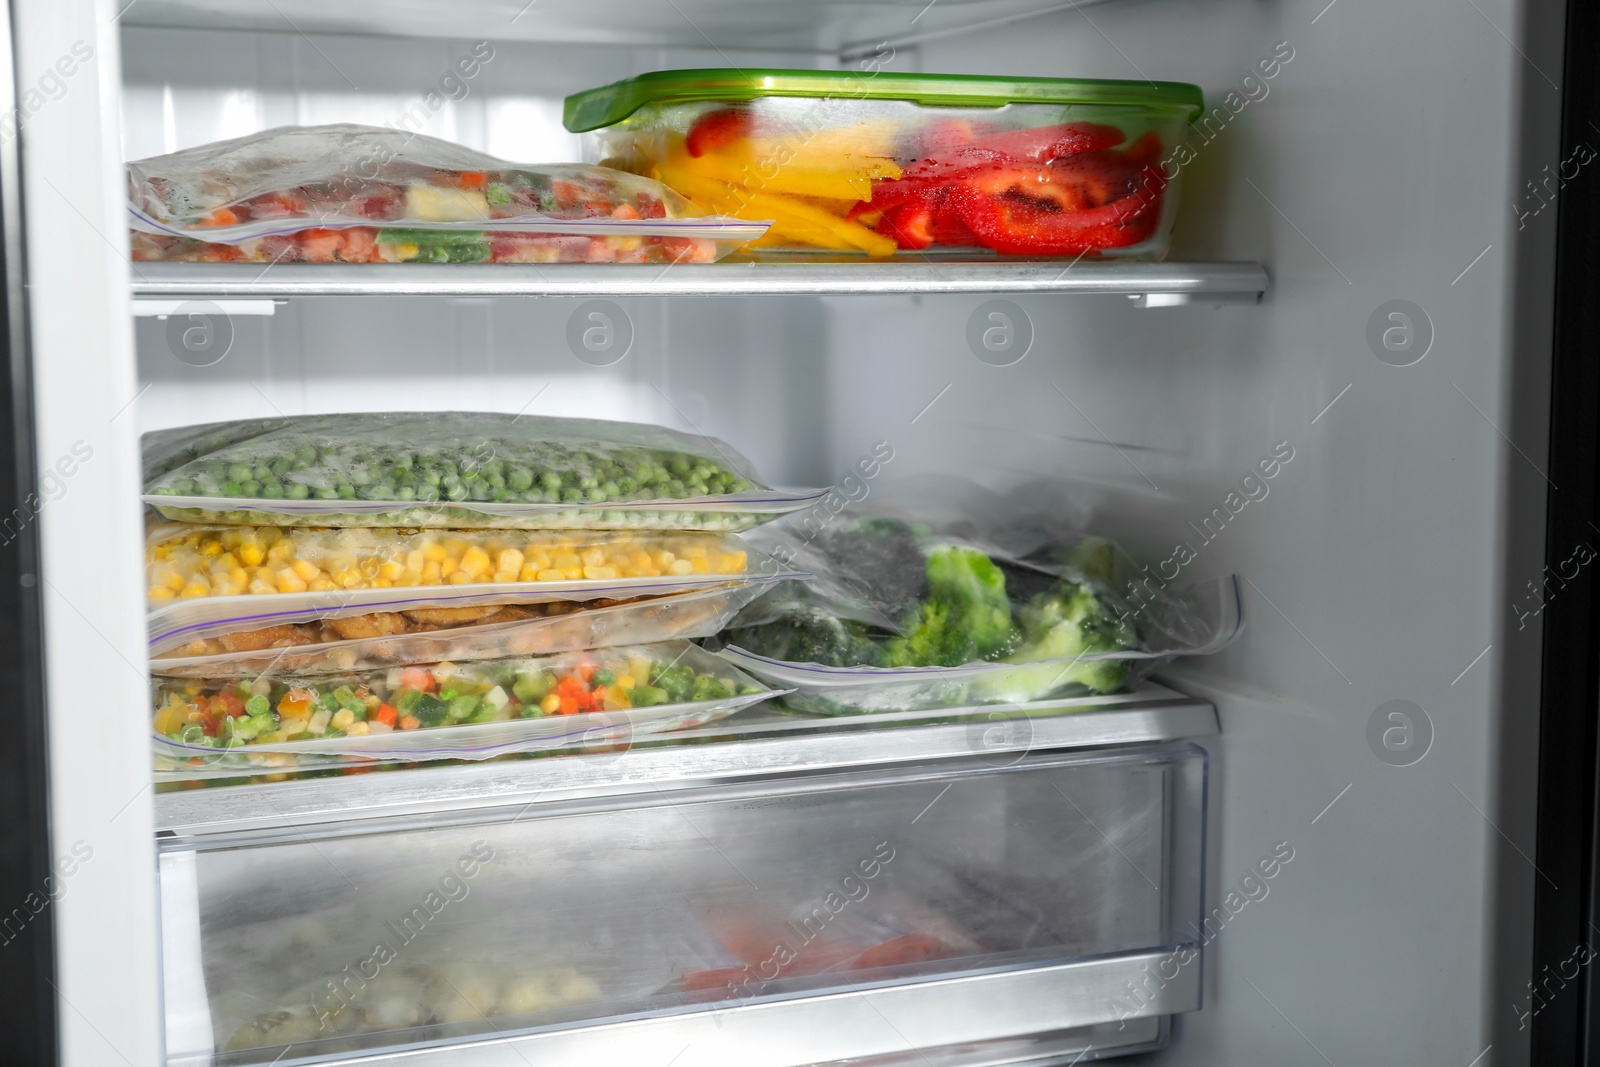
[152,641,766,749]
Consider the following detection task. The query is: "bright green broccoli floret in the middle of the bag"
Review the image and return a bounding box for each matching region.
[885,545,1013,667]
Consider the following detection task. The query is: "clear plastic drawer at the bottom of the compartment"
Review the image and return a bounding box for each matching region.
[162,744,1206,1067]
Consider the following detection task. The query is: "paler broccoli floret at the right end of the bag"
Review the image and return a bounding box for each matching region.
[1006,579,1136,693]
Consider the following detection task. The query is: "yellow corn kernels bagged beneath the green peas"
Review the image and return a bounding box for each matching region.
[146,525,749,601]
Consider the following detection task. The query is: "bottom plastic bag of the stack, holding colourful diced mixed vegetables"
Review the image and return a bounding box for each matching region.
[152,641,774,765]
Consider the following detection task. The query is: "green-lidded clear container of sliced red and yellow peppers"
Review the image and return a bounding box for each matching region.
[566,70,1202,256]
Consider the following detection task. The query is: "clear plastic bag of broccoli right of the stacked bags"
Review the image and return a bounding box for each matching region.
[707,517,1242,713]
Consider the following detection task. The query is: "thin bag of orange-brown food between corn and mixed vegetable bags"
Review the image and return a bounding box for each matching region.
[150,581,773,678]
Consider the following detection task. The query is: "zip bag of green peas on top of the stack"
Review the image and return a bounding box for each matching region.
[144,411,826,530]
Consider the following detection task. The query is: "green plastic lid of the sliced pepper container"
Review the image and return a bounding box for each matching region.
[563,67,1205,133]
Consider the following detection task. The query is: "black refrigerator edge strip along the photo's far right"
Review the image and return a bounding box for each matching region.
[1529,2,1600,1065]
